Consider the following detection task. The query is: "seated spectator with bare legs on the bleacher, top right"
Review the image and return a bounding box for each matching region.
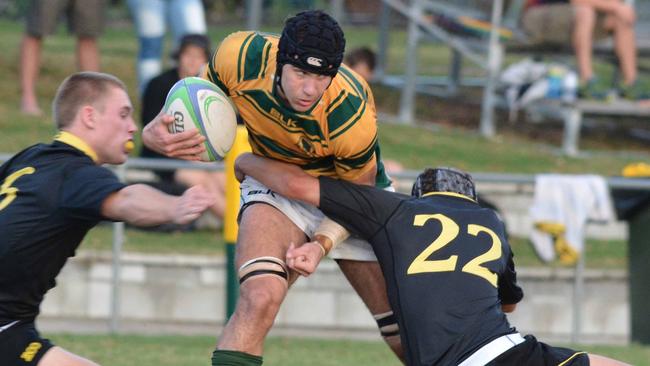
[522,0,649,100]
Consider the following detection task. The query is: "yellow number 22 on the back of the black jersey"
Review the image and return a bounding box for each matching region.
[406,214,501,287]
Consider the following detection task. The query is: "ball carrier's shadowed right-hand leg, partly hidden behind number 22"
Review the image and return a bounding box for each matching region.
[337,259,404,361]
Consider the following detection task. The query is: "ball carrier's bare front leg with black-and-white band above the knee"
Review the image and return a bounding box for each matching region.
[213,203,307,358]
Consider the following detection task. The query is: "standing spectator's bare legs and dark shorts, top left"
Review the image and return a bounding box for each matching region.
[20,0,106,116]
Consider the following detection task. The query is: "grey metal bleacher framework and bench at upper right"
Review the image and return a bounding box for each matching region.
[377,0,650,155]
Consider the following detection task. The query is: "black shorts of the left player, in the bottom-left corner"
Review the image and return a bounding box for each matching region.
[0,321,54,366]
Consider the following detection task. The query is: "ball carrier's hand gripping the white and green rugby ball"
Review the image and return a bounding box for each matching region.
[142,111,205,160]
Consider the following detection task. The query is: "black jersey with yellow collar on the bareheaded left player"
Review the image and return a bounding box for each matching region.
[0,132,124,325]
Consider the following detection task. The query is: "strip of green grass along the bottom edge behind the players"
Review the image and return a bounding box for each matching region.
[49,334,650,366]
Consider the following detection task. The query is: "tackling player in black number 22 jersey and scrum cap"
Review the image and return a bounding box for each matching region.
[235,153,624,366]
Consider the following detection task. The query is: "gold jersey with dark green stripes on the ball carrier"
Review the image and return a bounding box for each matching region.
[203,31,389,186]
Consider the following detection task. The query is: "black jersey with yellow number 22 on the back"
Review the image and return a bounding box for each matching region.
[319,177,523,366]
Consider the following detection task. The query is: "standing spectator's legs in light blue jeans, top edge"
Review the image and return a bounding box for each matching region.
[128,0,206,93]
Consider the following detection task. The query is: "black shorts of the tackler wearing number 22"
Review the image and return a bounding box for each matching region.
[488,335,589,366]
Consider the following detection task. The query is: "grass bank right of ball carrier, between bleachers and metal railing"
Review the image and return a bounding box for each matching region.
[379,124,650,176]
